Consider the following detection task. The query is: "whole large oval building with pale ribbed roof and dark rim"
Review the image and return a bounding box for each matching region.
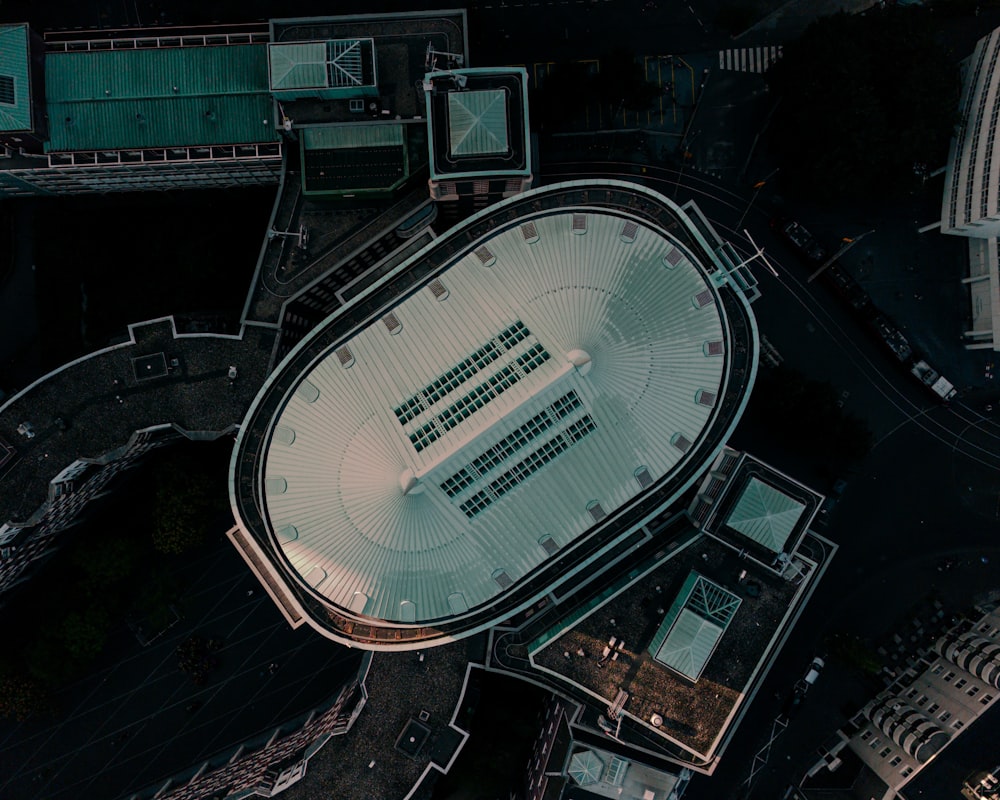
[231,181,757,649]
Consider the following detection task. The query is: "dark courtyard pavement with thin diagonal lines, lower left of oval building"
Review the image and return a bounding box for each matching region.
[0,537,361,800]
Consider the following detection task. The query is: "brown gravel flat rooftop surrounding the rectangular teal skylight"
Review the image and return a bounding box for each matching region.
[528,538,799,760]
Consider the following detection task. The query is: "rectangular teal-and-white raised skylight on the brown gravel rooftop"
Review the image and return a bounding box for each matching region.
[649,571,742,680]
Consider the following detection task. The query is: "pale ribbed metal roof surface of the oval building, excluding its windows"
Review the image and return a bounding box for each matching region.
[264,210,726,622]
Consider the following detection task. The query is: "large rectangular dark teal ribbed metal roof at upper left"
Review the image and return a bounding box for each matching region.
[45,44,278,151]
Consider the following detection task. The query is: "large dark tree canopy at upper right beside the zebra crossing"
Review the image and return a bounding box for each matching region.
[769,7,959,201]
